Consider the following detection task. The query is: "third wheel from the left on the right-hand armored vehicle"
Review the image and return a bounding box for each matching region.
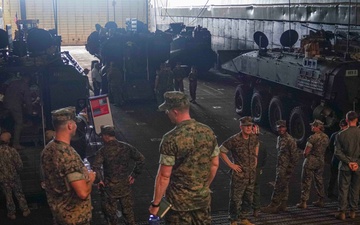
[268,96,288,132]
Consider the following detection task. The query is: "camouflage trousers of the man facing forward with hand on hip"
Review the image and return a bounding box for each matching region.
[229,173,255,221]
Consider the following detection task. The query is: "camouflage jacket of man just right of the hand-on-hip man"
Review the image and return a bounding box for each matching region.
[276,132,299,167]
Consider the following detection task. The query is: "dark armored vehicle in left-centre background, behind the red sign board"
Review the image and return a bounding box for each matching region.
[86,22,171,105]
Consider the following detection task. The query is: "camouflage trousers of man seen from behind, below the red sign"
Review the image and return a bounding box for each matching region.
[101,192,136,225]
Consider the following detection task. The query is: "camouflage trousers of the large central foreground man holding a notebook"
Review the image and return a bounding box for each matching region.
[165,206,211,225]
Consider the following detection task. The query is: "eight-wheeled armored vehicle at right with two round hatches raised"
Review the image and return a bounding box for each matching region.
[222,30,360,146]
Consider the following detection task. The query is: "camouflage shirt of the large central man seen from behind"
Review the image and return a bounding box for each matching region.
[159,119,219,211]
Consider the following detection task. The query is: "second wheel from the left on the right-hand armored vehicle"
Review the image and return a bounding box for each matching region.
[251,91,269,124]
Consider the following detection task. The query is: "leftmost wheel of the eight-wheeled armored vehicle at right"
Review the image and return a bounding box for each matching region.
[235,85,251,116]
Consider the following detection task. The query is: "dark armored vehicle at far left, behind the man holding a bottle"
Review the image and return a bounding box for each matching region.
[0,25,90,195]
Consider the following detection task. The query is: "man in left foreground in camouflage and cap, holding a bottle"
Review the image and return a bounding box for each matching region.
[41,107,95,225]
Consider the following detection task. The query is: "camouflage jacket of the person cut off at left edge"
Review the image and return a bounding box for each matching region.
[0,144,23,183]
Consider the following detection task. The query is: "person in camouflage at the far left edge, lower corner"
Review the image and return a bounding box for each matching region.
[0,133,30,219]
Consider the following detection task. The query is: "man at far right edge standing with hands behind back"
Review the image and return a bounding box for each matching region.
[335,111,360,220]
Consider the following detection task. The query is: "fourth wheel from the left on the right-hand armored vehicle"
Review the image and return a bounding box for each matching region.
[289,106,311,148]
